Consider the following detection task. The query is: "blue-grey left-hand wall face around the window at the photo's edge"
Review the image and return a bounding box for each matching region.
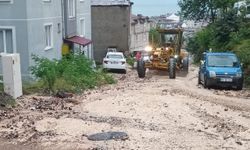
[0,0,29,75]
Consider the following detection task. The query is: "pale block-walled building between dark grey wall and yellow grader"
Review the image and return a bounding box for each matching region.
[130,15,152,52]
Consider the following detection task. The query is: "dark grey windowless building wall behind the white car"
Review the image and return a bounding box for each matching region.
[91,5,131,62]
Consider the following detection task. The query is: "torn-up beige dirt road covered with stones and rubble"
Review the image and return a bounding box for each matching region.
[0,68,250,150]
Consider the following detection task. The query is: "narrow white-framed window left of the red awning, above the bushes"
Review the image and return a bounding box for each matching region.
[45,24,53,50]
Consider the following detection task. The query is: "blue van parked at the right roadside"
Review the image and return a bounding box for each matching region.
[198,52,243,90]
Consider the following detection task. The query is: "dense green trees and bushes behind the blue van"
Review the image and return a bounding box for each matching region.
[179,0,250,85]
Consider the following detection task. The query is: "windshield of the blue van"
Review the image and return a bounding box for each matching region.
[208,55,238,67]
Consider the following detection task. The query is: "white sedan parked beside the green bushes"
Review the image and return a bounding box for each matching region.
[103,52,127,73]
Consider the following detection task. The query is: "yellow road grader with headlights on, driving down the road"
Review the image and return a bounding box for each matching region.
[137,28,189,79]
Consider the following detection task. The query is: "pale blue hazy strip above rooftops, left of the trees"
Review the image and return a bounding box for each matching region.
[131,0,179,16]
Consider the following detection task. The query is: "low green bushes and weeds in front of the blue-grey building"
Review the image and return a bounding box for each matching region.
[31,55,115,93]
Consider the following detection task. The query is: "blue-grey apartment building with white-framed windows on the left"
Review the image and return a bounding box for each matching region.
[0,0,91,77]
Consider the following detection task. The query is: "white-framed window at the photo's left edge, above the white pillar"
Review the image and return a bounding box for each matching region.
[0,28,15,53]
